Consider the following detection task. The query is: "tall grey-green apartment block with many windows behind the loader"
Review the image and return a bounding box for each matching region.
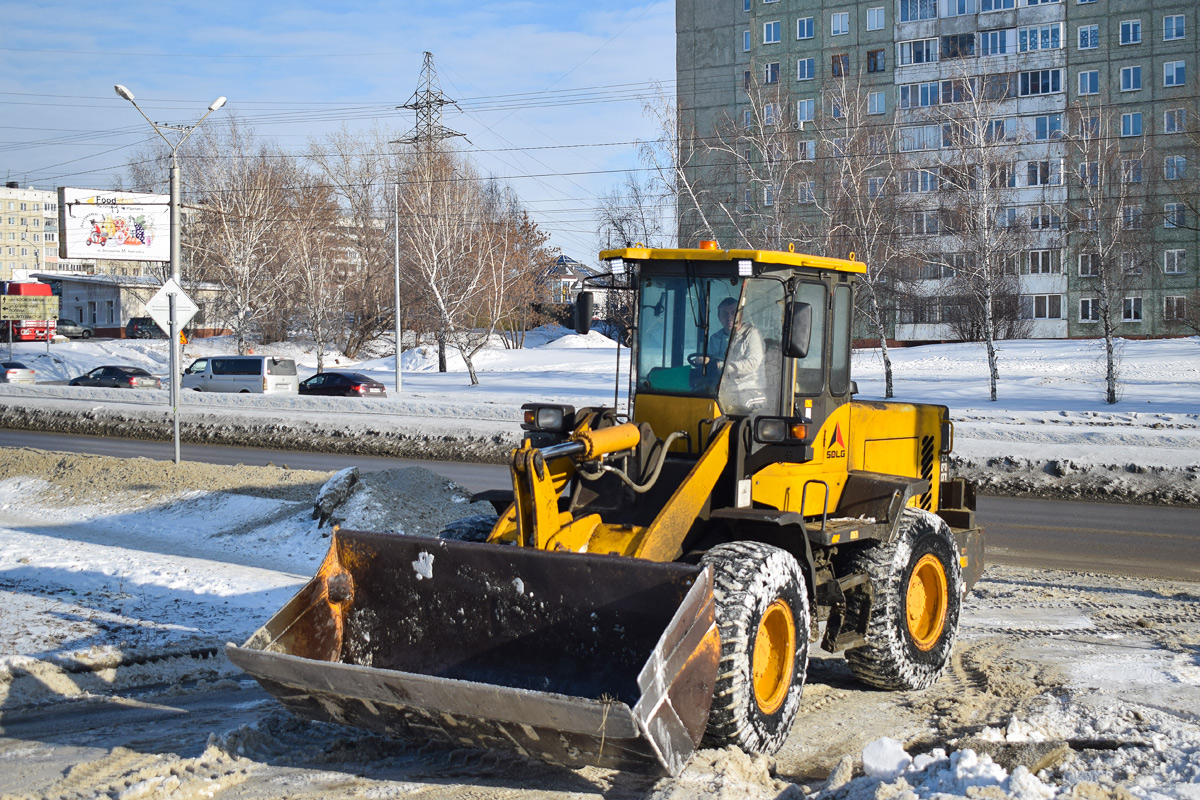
[676,0,1200,341]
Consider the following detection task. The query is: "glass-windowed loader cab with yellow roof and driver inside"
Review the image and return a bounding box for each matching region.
[601,248,865,455]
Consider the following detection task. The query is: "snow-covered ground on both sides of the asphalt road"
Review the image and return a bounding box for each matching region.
[0,331,1200,800]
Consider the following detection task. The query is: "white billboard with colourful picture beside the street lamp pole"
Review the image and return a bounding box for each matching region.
[59,187,170,261]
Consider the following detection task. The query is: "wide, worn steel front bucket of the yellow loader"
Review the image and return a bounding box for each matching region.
[226,530,720,775]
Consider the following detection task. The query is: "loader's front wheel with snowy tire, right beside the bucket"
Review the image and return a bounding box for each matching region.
[703,542,809,753]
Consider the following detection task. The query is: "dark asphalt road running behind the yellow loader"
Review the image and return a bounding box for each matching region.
[0,429,1200,581]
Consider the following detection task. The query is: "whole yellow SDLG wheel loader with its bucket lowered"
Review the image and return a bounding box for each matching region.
[227,242,983,774]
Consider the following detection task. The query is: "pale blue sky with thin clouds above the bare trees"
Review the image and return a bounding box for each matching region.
[0,0,674,263]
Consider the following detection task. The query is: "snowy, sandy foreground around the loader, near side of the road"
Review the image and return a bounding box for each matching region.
[0,450,1200,800]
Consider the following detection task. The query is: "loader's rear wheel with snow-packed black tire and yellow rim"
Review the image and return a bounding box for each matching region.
[846,509,962,690]
